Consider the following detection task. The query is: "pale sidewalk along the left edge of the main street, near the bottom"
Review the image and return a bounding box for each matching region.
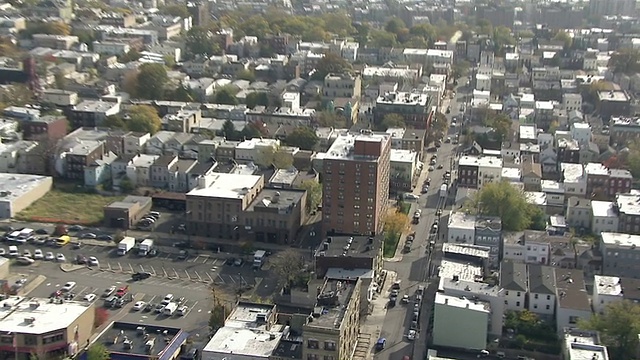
[353,270,397,360]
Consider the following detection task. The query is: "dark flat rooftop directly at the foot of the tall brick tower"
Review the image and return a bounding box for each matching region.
[316,236,382,258]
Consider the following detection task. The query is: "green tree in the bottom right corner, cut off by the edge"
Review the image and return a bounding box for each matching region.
[578,300,640,359]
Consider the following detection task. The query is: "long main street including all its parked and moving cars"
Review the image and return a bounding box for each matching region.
[375,79,464,360]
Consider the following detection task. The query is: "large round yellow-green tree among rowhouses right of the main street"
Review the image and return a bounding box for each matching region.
[469,181,535,231]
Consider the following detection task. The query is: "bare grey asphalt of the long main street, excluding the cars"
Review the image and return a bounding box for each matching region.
[374,82,464,360]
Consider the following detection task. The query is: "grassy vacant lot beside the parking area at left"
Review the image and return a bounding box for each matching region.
[16,189,124,225]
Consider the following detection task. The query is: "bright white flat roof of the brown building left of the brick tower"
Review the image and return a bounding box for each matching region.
[187,173,262,199]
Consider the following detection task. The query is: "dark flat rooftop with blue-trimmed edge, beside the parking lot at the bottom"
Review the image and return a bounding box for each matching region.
[95,322,189,359]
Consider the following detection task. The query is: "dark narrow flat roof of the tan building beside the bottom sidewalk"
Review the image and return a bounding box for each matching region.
[306,279,356,329]
